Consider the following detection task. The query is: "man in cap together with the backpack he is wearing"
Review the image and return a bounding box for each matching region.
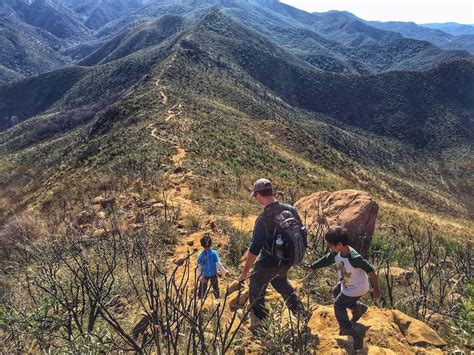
[239,179,309,332]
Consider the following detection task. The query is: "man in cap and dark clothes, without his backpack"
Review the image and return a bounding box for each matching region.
[239,179,308,332]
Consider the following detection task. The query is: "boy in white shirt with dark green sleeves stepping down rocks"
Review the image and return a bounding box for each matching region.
[310,227,380,349]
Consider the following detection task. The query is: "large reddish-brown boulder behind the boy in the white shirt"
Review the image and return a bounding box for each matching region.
[295,190,379,257]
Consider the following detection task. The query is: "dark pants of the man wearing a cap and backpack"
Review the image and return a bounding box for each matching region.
[249,264,304,320]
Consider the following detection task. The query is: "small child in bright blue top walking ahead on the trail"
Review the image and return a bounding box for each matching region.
[197,234,229,299]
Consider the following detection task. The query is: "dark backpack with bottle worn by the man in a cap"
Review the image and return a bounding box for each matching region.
[264,204,307,266]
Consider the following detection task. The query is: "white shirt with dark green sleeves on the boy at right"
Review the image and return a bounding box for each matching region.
[311,247,374,297]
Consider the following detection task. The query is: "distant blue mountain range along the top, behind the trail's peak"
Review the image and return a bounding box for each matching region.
[0,0,474,83]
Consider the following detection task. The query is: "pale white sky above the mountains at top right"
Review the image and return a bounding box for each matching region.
[280,0,474,24]
